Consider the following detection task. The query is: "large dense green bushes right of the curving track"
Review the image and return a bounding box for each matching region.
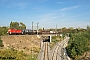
[66,32,90,60]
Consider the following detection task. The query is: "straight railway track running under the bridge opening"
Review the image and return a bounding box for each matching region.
[37,42,50,60]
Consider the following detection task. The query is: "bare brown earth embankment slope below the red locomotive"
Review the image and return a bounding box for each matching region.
[1,35,40,54]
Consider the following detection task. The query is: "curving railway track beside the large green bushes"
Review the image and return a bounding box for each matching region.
[51,39,68,60]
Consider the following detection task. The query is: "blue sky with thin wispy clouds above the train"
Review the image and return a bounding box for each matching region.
[0,0,90,28]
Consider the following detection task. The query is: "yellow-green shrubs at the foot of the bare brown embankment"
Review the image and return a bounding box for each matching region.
[0,49,37,60]
